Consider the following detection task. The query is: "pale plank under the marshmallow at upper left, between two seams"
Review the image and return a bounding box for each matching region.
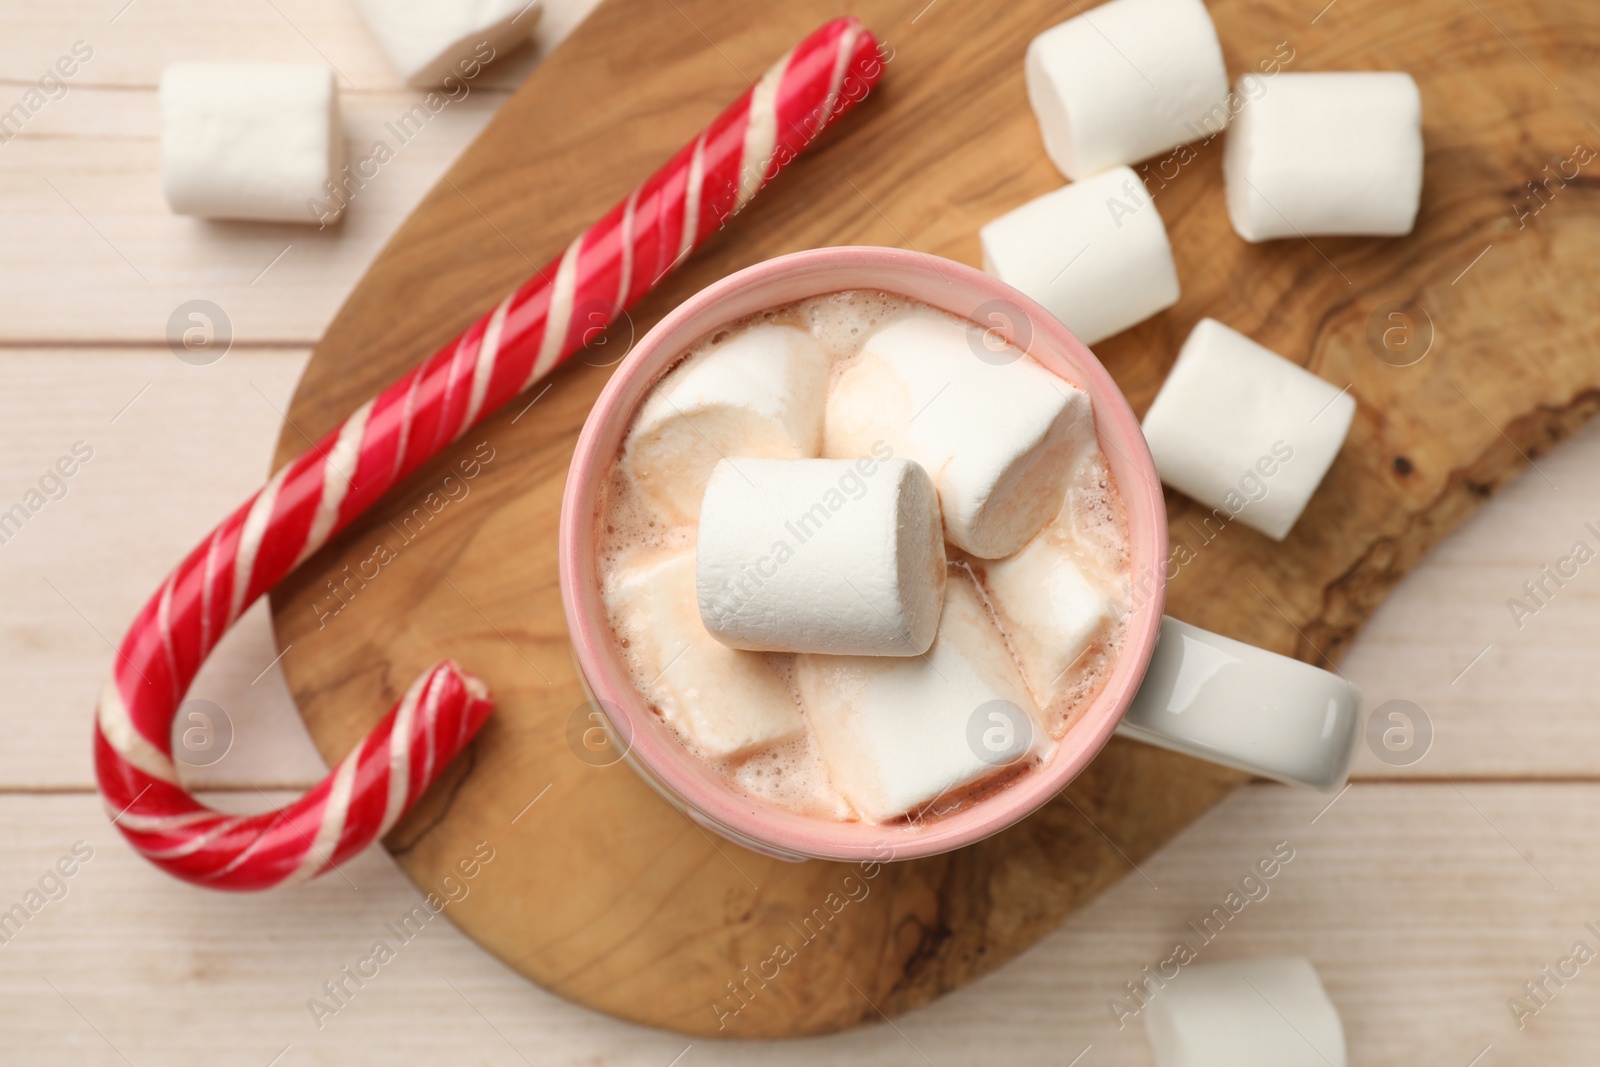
[0,90,504,346]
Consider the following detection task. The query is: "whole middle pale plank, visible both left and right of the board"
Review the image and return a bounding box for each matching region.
[9,347,1600,789]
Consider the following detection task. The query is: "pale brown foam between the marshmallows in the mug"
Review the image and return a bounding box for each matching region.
[597,290,1130,821]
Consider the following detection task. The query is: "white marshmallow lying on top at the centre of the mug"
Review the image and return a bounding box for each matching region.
[696,456,946,656]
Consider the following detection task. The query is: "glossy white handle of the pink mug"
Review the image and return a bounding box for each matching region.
[1117,616,1362,792]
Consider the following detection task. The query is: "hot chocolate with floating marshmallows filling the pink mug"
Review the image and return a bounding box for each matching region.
[597,290,1130,822]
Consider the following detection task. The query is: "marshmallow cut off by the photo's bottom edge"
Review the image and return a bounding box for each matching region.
[1144,957,1347,1067]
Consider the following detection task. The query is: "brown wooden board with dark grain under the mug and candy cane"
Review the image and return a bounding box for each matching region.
[274,0,1600,1037]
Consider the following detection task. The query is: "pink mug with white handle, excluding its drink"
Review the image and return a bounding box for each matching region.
[560,248,1360,861]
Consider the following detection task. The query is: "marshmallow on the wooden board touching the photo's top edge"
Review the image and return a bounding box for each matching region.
[1027,0,1229,178]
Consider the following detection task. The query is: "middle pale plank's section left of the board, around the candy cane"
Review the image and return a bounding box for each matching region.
[0,347,325,789]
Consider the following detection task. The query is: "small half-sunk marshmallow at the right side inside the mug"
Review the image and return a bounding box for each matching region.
[984,526,1112,704]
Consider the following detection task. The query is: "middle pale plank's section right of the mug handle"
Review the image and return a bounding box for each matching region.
[1341,415,1600,777]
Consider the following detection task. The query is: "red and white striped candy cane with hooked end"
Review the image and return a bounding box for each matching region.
[94,19,882,889]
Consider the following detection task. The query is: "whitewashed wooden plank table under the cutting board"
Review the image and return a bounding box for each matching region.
[0,0,1600,1067]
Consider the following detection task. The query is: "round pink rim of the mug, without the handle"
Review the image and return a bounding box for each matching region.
[558,245,1168,862]
